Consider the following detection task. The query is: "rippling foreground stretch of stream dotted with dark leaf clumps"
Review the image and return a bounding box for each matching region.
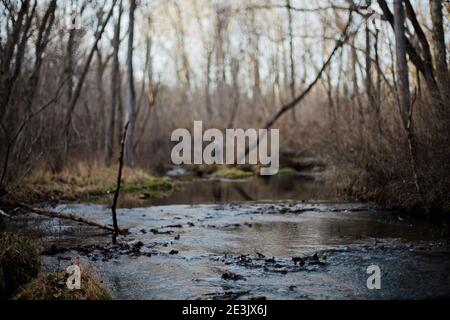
[18,202,450,299]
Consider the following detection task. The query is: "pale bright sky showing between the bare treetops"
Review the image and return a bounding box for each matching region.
[103,0,449,89]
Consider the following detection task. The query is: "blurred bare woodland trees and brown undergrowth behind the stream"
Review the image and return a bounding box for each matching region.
[0,0,450,213]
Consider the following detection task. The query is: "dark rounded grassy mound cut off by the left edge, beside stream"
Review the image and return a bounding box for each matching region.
[0,232,40,300]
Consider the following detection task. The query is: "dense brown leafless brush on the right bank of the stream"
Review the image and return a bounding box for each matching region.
[318,94,450,217]
